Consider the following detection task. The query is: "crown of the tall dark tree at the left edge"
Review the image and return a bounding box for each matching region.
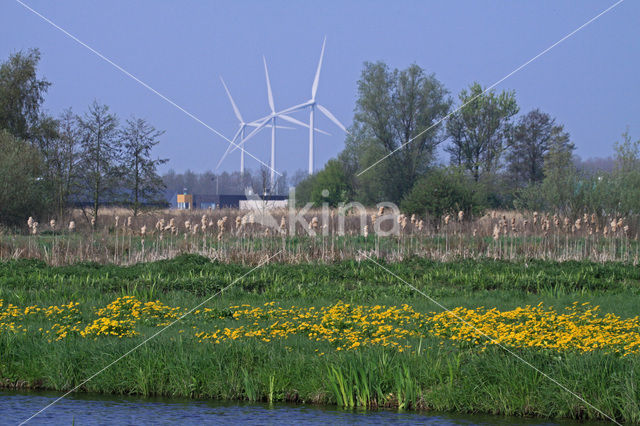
[0,49,51,141]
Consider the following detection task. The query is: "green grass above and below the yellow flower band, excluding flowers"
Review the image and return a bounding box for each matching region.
[0,255,640,423]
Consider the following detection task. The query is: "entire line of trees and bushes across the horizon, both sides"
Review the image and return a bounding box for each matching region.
[0,49,640,224]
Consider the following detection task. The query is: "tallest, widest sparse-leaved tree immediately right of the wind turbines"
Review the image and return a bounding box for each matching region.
[347,62,451,202]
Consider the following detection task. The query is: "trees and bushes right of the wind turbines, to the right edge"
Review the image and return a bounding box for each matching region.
[296,62,640,220]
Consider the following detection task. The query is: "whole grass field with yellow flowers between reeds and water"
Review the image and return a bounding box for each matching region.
[0,255,640,423]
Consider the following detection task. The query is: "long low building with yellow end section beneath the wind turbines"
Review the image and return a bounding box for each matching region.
[176,191,289,210]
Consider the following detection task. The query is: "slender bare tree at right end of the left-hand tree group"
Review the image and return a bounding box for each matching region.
[121,118,169,216]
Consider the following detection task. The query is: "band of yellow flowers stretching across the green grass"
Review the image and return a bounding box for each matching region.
[0,296,640,356]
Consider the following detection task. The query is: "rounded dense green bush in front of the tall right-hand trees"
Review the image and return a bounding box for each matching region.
[400,167,486,219]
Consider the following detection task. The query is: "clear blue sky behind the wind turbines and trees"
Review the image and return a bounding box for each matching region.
[0,0,640,174]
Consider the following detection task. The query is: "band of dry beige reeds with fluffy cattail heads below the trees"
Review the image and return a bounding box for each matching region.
[0,209,640,265]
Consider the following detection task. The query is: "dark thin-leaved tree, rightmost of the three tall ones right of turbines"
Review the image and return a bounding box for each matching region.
[507,109,557,186]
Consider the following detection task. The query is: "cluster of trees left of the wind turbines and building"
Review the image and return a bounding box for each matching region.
[0,49,167,226]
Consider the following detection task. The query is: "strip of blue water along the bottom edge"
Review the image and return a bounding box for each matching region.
[0,391,604,426]
